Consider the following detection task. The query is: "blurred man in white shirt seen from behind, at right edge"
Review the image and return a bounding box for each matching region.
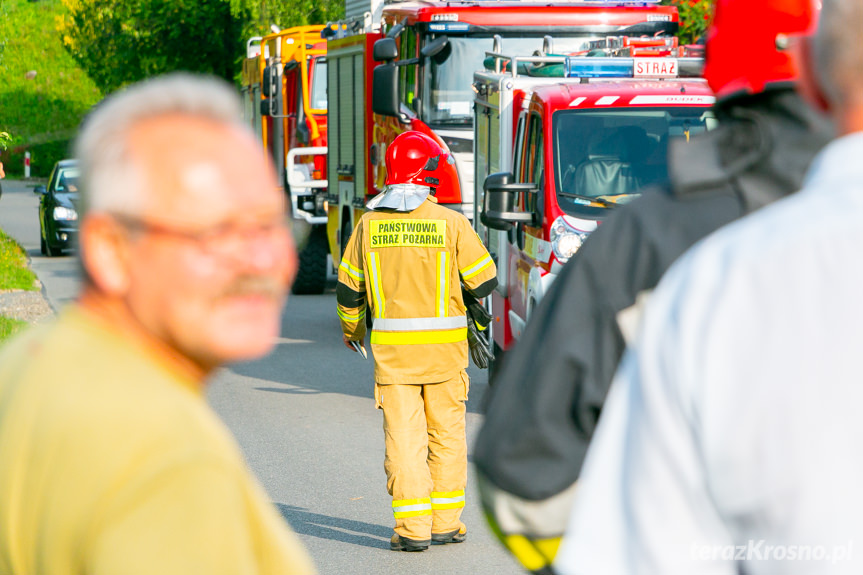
[555,0,863,575]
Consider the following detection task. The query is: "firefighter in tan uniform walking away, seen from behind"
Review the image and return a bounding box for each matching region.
[336,131,497,551]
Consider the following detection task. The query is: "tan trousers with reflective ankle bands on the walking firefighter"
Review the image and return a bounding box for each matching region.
[375,371,470,541]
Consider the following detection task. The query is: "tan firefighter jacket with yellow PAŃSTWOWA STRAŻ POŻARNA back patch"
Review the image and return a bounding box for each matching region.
[336,196,497,384]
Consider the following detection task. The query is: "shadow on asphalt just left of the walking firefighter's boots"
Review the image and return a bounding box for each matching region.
[276,503,393,549]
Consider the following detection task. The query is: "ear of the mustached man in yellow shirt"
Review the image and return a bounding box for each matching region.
[78,214,131,296]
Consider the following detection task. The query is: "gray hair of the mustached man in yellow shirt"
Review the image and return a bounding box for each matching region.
[74,72,248,214]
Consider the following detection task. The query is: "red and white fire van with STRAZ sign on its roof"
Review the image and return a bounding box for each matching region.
[480,37,715,354]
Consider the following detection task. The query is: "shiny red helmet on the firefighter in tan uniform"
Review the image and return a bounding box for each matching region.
[385,131,452,187]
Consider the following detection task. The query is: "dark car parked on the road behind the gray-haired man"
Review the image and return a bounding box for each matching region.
[33,160,78,256]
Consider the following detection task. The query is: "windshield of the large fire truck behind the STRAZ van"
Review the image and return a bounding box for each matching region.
[422,35,599,126]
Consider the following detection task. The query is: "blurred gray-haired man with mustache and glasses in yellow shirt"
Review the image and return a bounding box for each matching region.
[0,75,314,575]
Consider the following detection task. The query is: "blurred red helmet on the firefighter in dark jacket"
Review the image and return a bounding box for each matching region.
[704,0,818,99]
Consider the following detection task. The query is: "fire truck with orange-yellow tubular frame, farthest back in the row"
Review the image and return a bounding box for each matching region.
[242,26,329,294]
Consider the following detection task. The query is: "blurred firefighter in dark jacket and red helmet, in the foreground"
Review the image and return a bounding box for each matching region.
[474,0,832,573]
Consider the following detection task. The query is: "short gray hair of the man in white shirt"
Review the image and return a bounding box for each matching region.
[813,0,863,106]
